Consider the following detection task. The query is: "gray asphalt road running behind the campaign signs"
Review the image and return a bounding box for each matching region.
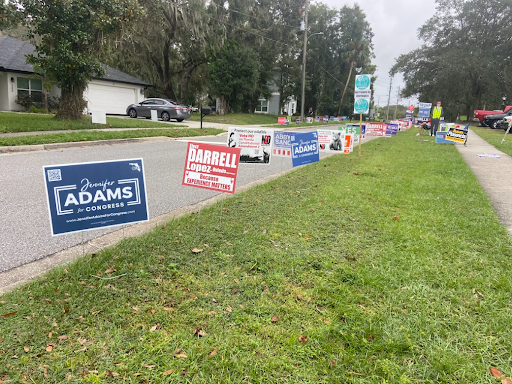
[0,131,364,272]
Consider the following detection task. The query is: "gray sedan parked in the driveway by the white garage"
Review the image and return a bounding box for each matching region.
[126,98,190,122]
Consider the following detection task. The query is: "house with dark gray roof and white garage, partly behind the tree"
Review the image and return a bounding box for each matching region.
[0,36,150,115]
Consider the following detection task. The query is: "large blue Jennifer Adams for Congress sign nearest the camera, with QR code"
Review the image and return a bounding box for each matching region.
[43,159,149,236]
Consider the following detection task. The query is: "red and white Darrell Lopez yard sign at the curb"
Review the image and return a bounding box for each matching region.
[182,142,240,193]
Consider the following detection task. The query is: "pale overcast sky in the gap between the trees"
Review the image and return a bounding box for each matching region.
[321,0,435,105]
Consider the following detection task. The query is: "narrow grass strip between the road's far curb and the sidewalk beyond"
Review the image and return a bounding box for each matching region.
[0,128,225,146]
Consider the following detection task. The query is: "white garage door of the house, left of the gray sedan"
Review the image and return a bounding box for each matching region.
[84,83,138,115]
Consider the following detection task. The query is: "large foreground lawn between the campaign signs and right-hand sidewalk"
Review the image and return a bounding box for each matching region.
[0,130,512,384]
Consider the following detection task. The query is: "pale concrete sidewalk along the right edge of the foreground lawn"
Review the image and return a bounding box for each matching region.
[456,130,512,236]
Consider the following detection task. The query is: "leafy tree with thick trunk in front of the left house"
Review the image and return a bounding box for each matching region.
[4,0,140,119]
